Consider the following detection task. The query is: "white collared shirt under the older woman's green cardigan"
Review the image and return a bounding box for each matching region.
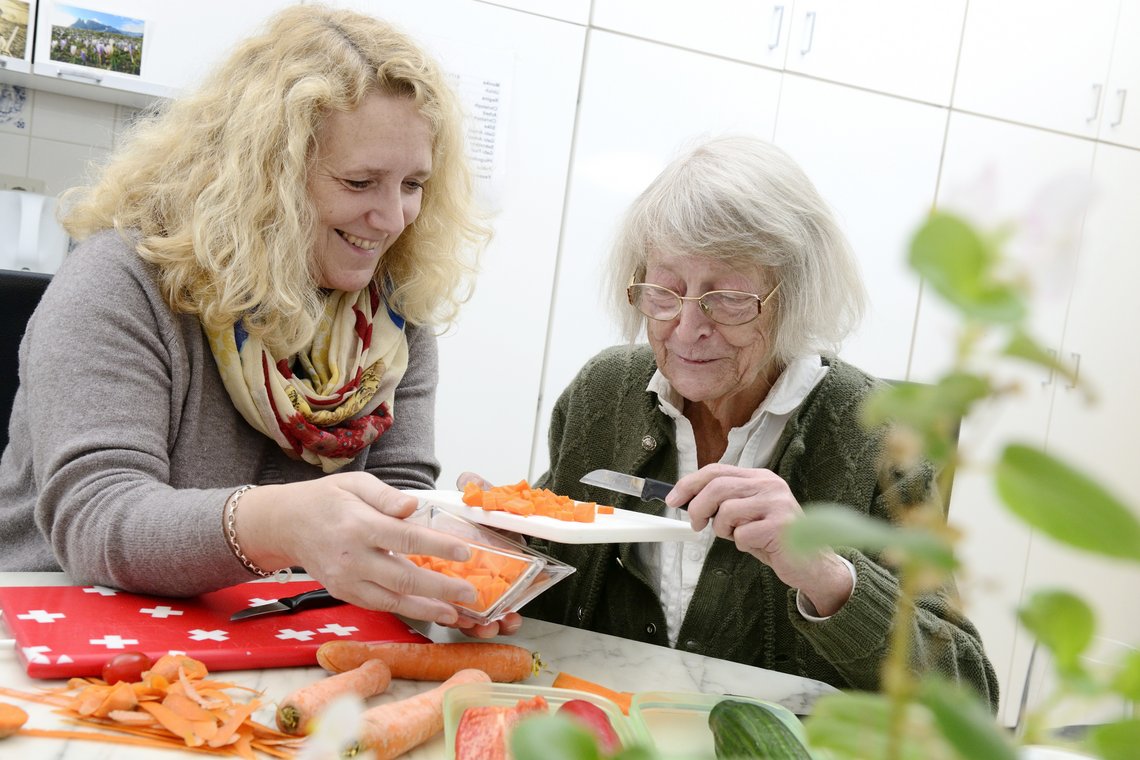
[637,354,834,646]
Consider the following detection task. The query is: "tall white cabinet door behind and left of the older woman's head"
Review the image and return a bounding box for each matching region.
[530,32,780,476]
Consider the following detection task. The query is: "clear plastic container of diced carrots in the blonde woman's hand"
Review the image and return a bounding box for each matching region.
[405,504,575,623]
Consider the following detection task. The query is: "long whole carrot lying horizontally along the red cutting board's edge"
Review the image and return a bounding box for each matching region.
[317,640,543,684]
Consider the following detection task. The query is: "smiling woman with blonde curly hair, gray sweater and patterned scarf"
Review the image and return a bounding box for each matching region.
[0,6,487,623]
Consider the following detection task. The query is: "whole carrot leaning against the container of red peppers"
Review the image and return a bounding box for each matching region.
[344,668,490,760]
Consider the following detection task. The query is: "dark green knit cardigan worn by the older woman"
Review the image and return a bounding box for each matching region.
[522,346,998,710]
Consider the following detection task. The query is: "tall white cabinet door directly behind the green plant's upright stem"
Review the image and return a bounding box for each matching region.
[911,113,1093,725]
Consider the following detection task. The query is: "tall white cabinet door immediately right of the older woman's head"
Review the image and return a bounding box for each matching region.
[775,74,947,379]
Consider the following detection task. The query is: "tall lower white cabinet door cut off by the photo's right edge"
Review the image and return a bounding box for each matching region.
[1021,145,1140,697]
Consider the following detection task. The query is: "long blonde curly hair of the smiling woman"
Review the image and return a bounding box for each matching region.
[62,5,490,356]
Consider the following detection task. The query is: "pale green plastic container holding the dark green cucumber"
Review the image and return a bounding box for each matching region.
[629,692,806,759]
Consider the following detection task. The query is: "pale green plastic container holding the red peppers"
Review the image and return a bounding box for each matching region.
[443,684,647,759]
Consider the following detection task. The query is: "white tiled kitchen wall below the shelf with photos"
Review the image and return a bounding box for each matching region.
[0,84,136,195]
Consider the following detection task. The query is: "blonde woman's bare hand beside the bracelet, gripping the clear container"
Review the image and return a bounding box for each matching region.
[237,473,475,626]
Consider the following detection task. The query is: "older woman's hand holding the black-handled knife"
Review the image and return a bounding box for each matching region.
[666,464,852,616]
